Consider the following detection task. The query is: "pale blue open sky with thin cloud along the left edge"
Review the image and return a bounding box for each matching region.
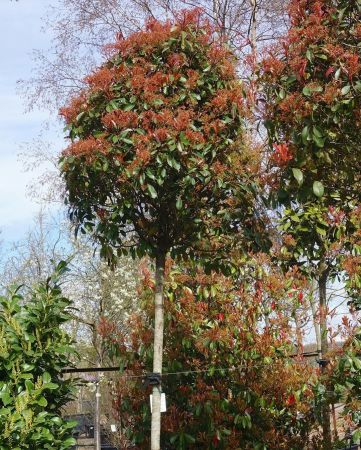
[0,0,61,244]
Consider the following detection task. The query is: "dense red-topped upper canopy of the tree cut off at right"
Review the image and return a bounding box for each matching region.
[262,0,361,202]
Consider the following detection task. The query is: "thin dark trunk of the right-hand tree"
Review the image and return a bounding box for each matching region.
[318,269,332,450]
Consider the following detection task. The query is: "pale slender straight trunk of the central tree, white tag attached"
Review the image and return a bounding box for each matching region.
[151,253,165,450]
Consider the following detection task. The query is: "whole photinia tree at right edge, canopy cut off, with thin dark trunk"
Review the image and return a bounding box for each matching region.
[261,0,361,448]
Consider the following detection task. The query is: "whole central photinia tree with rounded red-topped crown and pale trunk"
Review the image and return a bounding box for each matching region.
[60,10,257,450]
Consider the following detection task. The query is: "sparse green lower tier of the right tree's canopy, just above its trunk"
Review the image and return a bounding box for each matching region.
[280,201,361,282]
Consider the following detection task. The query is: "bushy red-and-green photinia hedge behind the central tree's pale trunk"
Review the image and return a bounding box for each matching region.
[100,255,319,450]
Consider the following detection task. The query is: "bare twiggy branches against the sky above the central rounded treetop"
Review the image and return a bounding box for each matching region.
[19,0,287,111]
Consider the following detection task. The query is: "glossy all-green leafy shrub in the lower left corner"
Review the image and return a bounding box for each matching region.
[0,263,75,450]
